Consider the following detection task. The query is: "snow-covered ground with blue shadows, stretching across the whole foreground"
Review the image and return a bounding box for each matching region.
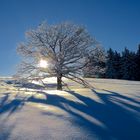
[0,78,140,140]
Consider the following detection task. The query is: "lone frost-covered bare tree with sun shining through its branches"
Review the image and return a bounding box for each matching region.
[17,22,97,90]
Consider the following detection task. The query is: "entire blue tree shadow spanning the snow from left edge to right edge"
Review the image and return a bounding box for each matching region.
[0,89,140,140]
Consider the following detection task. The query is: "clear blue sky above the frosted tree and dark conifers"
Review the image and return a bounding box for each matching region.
[0,0,140,76]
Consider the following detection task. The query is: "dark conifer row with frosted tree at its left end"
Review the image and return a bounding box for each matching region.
[84,45,140,81]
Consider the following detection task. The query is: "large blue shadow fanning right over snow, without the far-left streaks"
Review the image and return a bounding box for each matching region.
[28,89,140,140]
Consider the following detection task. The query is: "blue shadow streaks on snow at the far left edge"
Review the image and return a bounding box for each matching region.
[0,93,24,140]
